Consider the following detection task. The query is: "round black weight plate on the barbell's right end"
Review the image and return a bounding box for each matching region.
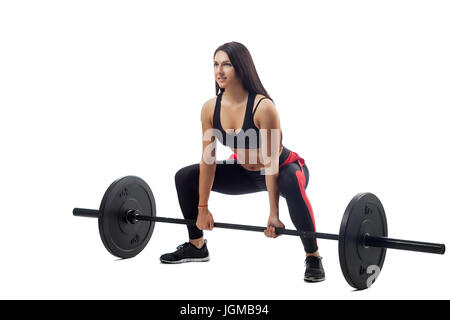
[339,193,388,290]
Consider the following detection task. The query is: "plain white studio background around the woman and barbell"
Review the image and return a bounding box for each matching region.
[0,0,450,299]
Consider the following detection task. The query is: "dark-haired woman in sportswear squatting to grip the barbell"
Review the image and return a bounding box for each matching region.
[161,42,325,282]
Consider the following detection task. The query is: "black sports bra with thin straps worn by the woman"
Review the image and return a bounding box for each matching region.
[213,92,268,149]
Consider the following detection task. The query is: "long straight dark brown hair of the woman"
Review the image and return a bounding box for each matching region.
[213,41,273,102]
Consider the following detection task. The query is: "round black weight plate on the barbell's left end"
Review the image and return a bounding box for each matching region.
[98,176,156,259]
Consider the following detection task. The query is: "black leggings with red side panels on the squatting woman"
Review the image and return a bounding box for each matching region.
[175,147,318,253]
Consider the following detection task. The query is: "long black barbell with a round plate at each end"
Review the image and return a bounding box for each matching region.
[73,176,445,290]
